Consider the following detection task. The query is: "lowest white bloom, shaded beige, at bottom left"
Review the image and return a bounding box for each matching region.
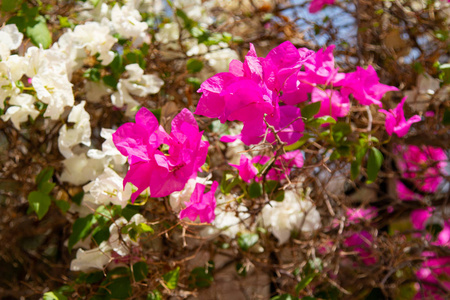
[70,241,112,272]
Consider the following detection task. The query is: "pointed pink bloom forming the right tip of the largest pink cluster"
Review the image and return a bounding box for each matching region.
[336,66,398,107]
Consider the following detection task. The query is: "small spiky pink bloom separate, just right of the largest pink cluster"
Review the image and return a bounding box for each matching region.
[380,97,422,137]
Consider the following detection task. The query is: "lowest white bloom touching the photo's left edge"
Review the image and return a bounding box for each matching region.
[1,94,39,129]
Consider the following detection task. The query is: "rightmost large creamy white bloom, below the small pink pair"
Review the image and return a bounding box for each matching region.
[262,190,321,245]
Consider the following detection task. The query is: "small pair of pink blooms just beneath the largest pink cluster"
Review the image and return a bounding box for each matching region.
[230,150,303,182]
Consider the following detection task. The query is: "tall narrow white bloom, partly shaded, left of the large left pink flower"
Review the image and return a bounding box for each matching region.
[58,101,91,158]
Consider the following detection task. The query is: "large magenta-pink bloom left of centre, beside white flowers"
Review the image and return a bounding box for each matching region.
[113,108,209,201]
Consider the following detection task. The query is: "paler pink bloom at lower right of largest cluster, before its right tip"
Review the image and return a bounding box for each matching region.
[311,88,350,120]
